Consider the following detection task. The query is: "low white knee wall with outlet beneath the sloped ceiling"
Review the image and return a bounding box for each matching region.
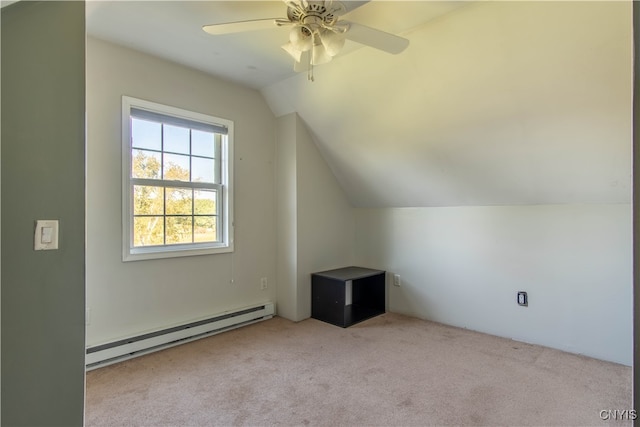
[356,204,633,365]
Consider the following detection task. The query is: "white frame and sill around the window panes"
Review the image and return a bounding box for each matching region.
[122,95,234,262]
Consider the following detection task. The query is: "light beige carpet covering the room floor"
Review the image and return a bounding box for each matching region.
[86,313,631,426]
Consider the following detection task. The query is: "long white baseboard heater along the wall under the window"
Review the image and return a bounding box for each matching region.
[85,303,274,370]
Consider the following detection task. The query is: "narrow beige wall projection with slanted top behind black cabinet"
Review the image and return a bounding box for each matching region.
[277,114,355,321]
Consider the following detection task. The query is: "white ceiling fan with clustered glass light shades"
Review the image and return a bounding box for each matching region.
[202,0,409,81]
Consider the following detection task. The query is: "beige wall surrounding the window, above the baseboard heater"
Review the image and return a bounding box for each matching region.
[87,38,276,345]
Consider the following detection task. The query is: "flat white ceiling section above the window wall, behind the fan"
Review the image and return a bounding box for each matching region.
[86,0,464,89]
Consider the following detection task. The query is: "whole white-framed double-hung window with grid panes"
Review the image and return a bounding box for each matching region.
[122,96,233,261]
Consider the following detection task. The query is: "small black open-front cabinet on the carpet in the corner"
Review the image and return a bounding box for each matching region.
[311,267,385,328]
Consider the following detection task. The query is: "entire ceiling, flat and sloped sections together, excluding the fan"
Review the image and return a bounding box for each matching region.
[87,0,632,207]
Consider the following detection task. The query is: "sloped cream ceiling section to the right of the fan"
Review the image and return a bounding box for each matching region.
[263,2,632,207]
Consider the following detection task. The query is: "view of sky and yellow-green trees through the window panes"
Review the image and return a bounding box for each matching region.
[131,118,219,247]
